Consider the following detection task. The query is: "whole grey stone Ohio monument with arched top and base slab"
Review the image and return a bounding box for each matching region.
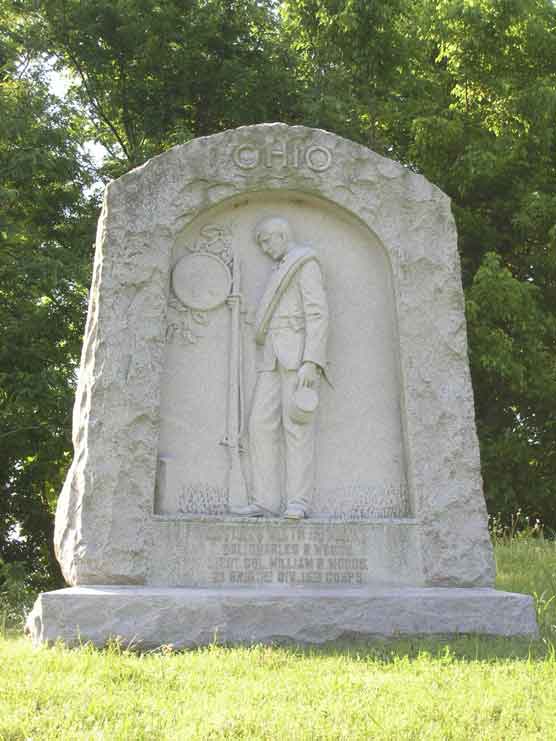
[27,124,537,646]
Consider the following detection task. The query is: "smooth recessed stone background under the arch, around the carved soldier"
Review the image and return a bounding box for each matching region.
[154,191,410,519]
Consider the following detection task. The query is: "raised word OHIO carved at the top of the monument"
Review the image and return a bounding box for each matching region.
[232,142,332,172]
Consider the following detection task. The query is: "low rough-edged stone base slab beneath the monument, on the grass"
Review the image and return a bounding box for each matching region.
[26,586,538,648]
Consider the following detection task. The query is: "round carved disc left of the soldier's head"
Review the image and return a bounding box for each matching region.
[172,252,232,311]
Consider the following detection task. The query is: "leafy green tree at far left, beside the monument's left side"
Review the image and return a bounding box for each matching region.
[0,4,97,586]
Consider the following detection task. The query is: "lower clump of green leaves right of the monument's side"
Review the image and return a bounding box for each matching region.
[467,253,556,527]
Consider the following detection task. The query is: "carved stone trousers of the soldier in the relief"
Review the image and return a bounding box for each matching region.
[249,363,316,514]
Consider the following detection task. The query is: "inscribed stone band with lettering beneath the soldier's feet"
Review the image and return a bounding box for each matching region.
[147,517,424,588]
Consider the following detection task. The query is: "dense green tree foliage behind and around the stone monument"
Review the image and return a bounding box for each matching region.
[0,0,556,590]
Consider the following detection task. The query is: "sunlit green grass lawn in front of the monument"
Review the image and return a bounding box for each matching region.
[0,539,556,741]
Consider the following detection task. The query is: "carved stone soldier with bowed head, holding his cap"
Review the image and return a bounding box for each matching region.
[233,217,328,519]
